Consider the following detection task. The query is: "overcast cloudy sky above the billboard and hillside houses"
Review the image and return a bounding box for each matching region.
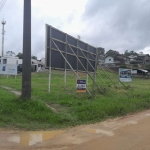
[0,0,150,59]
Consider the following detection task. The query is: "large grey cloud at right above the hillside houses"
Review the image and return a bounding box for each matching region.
[82,0,150,53]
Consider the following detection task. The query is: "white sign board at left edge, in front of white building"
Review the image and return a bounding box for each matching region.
[0,64,17,75]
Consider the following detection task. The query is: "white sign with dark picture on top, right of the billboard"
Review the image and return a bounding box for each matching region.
[119,68,132,82]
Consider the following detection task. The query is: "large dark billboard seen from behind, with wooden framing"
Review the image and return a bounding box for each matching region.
[45,25,97,72]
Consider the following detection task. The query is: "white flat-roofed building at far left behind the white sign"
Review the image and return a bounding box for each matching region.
[0,56,22,65]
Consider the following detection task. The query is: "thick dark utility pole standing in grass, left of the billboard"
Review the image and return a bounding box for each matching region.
[22,0,31,99]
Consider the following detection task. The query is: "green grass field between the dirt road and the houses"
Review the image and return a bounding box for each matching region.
[0,70,150,130]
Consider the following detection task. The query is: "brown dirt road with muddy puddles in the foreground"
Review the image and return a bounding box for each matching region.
[0,110,150,150]
